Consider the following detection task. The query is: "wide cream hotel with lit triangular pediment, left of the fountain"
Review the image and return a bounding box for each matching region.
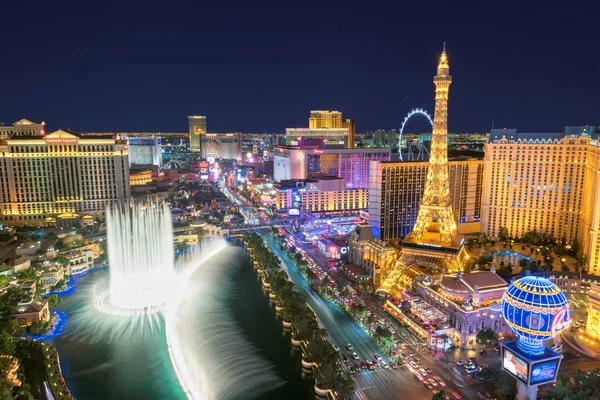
[0,130,131,225]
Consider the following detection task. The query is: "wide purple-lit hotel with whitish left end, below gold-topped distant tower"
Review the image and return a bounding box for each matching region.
[273,146,391,189]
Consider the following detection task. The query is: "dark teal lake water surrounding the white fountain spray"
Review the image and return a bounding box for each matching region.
[49,246,314,400]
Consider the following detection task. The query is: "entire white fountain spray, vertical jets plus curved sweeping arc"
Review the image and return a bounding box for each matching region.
[71,204,282,399]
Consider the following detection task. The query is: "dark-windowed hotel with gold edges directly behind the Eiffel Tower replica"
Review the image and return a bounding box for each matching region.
[369,158,484,241]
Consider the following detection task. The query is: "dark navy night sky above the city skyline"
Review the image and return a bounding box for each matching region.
[0,0,600,133]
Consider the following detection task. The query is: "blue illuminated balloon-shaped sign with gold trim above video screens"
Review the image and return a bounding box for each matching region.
[502,276,571,354]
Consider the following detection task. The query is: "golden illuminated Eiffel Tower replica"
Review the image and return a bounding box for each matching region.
[378,47,468,295]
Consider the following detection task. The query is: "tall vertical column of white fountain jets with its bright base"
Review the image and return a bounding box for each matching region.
[98,205,185,315]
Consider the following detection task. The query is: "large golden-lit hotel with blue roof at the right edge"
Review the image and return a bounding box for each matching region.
[482,126,600,274]
